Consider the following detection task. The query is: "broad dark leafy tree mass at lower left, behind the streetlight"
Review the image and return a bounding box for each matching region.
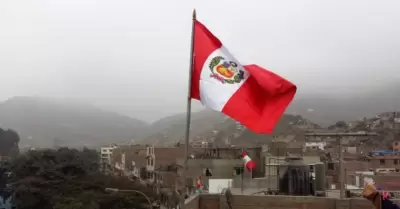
[6,148,156,209]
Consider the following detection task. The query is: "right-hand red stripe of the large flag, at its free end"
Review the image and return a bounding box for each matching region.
[222,65,296,133]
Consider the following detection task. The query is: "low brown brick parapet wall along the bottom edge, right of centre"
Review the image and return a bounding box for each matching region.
[187,194,400,209]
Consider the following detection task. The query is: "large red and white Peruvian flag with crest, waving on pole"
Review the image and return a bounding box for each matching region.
[191,21,296,134]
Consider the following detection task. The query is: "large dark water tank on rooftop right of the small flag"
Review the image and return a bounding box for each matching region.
[279,157,313,196]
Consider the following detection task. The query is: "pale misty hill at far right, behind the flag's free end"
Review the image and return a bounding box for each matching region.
[288,84,400,126]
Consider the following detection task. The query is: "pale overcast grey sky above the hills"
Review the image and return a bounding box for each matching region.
[0,0,400,121]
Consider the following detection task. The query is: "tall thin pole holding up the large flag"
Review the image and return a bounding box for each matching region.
[179,9,196,209]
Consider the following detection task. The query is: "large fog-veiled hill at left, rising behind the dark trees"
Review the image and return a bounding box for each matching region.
[0,97,147,147]
